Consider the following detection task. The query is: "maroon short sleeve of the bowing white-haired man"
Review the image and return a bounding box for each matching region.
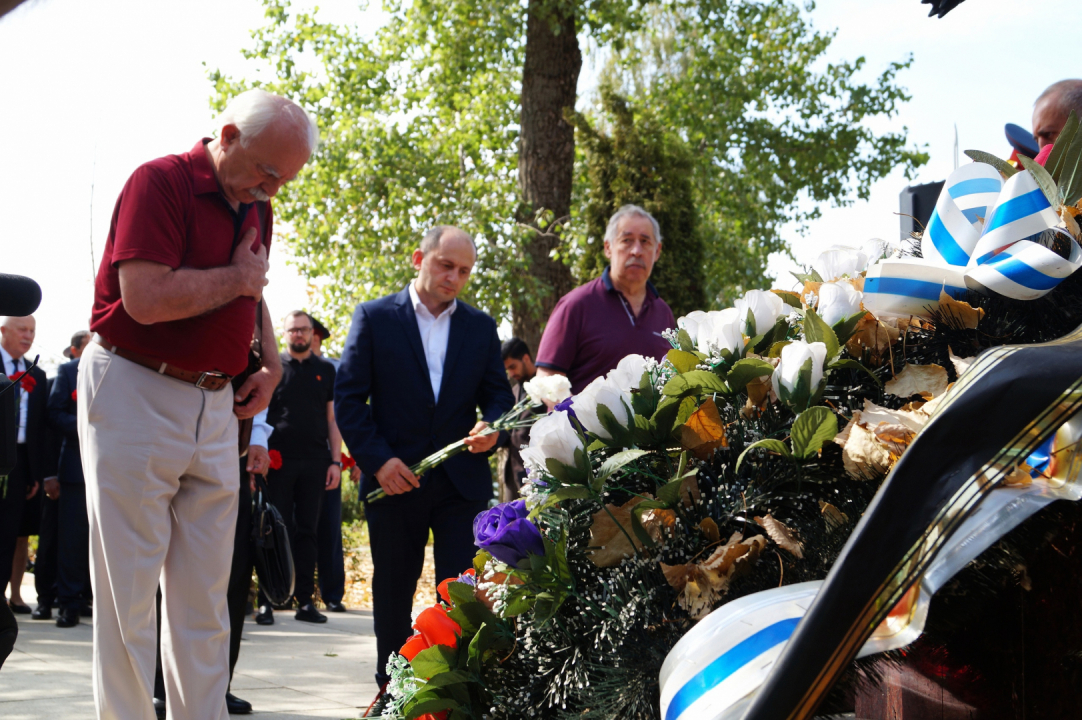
[111,165,190,270]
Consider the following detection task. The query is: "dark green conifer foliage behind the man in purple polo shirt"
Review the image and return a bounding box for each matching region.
[575,89,705,317]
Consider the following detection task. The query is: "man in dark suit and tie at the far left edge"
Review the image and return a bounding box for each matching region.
[0,315,45,615]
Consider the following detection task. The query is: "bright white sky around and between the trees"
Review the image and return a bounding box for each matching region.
[0,0,1082,368]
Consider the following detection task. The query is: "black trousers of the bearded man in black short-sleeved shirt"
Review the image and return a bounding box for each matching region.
[260,455,331,606]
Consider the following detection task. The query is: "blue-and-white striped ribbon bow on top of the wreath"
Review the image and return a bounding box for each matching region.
[863,162,1082,317]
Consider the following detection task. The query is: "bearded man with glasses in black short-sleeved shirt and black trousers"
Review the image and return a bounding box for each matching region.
[255,310,342,625]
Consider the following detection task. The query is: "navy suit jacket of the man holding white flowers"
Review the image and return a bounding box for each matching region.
[334,287,515,502]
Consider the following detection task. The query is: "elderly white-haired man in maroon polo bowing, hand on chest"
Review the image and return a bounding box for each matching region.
[78,90,318,720]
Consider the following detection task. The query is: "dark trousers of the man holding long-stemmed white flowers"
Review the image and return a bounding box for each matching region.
[365,468,488,685]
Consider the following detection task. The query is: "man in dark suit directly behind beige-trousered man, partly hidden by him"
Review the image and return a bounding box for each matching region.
[47,330,91,628]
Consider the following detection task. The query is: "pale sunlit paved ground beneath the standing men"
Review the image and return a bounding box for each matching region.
[0,575,377,720]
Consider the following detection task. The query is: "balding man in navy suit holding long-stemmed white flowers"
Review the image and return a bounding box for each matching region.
[334,226,515,686]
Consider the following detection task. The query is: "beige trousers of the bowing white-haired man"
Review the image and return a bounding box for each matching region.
[78,342,239,720]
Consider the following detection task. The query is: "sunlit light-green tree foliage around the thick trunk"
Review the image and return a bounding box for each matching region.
[211,0,924,348]
